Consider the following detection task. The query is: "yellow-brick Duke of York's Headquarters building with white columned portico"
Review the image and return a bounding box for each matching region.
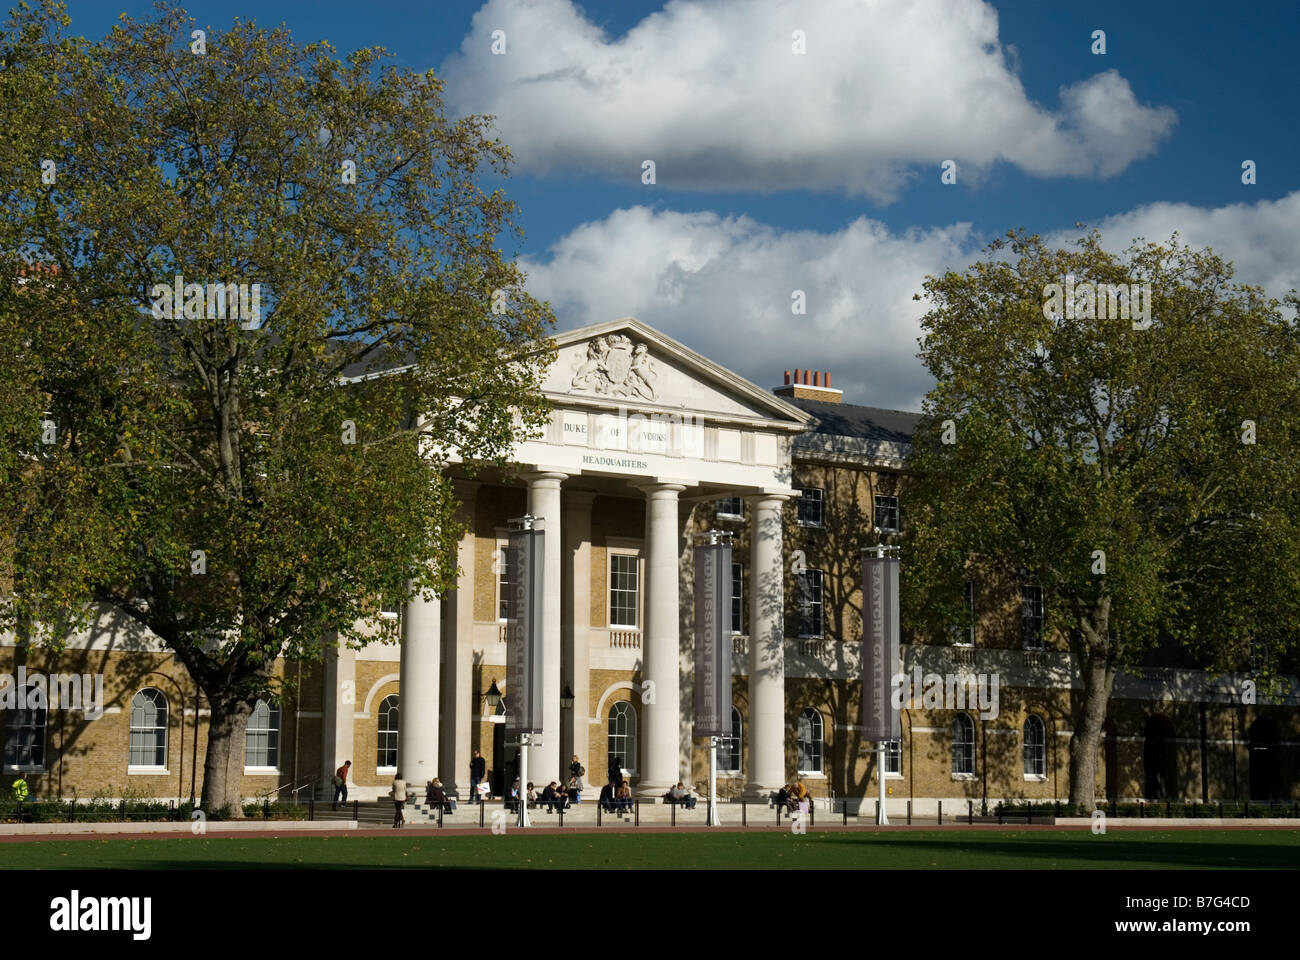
[0,319,1300,813]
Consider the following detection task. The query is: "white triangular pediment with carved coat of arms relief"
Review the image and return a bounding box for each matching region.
[542,317,813,429]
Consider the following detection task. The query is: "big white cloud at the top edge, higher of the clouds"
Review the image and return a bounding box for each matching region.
[439,0,1175,200]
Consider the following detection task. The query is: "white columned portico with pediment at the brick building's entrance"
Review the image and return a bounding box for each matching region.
[387,319,810,795]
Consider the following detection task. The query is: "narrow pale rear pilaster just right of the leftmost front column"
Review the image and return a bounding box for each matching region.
[438,480,478,801]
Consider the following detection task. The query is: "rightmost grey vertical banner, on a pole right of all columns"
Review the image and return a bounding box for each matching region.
[862,552,902,741]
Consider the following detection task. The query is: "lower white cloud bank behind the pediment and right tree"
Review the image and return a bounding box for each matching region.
[520,191,1300,410]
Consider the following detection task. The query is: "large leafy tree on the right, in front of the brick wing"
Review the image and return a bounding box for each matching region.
[904,233,1300,809]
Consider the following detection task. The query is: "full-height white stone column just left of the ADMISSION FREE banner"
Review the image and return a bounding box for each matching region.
[638,483,686,796]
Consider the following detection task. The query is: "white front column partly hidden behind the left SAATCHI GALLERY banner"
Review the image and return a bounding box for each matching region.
[525,471,568,784]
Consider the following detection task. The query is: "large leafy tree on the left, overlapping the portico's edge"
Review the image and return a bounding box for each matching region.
[0,3,553,810]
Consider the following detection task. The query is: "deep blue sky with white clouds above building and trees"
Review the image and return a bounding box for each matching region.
[69,0,1300,408]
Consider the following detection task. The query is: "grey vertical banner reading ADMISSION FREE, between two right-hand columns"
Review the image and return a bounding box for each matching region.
[694,544,732,736]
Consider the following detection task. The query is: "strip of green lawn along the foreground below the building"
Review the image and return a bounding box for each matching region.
[0,830,1300,870]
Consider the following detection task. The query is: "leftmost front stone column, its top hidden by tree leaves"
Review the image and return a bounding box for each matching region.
[398,582,442,791]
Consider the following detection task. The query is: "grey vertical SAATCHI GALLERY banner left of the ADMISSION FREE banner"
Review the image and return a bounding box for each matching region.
[506,529,543,735]
